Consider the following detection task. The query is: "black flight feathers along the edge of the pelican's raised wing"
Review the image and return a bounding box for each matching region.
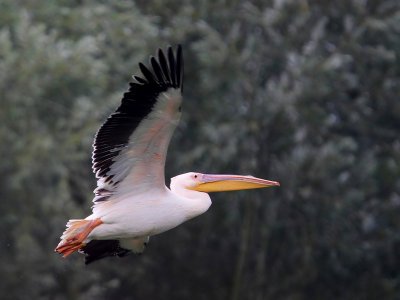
[92,46,183,184]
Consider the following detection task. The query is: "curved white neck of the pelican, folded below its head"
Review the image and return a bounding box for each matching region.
[170,181,211,219]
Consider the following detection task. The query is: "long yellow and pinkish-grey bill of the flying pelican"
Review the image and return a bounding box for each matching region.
[192,174,280,193]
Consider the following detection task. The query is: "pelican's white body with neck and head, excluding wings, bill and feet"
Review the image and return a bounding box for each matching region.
[87,173,211,240]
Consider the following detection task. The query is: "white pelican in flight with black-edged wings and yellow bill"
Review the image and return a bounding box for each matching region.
[55,45,279,264]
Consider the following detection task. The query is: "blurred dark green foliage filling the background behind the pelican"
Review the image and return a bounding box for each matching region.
[0,0,400,300]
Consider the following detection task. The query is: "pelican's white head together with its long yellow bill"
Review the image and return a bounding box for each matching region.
[171,172,279,193]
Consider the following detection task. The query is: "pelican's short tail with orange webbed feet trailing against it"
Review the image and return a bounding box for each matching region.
[55,219,103,257]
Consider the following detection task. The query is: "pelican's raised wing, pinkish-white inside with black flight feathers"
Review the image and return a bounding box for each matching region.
[92,45,183,202]
